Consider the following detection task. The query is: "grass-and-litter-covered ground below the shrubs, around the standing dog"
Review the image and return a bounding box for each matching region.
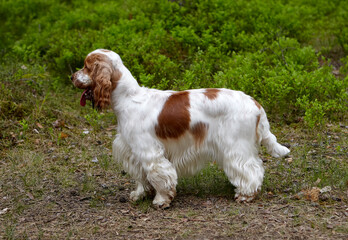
[0,97,348,239]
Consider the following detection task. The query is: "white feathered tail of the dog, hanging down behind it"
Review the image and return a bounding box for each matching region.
[256,106,290,157]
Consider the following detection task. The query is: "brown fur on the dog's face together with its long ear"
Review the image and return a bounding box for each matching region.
[83,53,122,109]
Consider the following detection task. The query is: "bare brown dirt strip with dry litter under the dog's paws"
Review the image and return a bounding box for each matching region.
[1,181,348,239]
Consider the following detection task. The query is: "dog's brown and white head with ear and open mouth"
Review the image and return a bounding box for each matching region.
[71,49,122,109]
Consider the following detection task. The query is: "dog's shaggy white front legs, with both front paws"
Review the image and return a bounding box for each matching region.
[121,132,178,208]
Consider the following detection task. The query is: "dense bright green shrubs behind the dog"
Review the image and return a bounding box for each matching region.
[0,0,348,127]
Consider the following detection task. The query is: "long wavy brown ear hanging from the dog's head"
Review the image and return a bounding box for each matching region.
[93,62,112,109]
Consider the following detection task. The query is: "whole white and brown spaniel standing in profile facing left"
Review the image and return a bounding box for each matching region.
[71,49,290,208]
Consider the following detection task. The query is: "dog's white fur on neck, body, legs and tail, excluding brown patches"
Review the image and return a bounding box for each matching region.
[77,50,290,207]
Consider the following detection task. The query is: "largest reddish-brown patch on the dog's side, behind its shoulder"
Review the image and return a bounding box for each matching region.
[155,91,190,139]
